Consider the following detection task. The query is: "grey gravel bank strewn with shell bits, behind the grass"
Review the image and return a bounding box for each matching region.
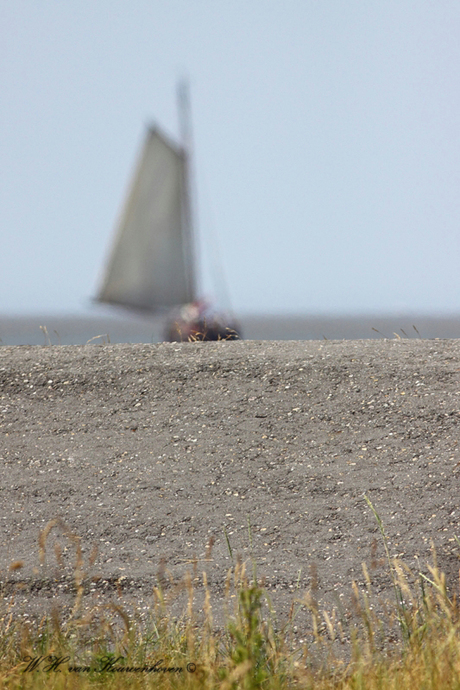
[0,339,460,619]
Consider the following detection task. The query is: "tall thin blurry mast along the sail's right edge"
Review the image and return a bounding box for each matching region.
[177,79,201,299]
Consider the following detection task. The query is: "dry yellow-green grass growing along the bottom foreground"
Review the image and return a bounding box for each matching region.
[0,502,460,690]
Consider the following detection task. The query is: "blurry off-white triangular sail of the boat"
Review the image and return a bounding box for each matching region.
[97,129,195,312]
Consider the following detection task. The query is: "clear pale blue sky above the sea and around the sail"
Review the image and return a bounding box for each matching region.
[0,0,460,315]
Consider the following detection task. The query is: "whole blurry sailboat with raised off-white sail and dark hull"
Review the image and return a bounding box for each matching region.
[96,84,240,341]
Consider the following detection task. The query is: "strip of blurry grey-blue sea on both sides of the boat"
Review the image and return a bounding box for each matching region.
[0,313,460,347]
